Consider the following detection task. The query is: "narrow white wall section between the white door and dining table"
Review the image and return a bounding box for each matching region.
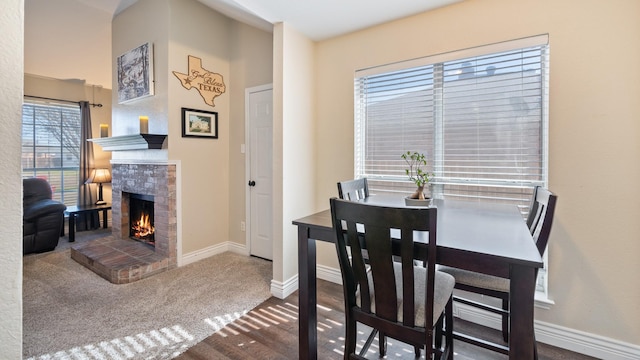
[273,23,316,295]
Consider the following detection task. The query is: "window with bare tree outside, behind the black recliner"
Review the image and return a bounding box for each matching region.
[22,103,81,206]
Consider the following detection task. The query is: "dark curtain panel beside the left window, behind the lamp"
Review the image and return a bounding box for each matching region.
[76,101,100,231]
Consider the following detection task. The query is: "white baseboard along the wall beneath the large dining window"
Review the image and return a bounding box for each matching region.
[317,265,640,360]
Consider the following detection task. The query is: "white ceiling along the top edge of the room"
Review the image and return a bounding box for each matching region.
[78,0,463,41]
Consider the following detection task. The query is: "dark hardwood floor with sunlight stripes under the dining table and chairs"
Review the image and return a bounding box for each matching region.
[176,280,593,360]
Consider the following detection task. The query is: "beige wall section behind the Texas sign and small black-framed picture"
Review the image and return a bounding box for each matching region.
[167,0,232,254]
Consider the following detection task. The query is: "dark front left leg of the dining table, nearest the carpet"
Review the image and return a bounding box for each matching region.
[298,226,318,360]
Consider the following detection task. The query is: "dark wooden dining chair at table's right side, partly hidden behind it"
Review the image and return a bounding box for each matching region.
[438,186,557,353]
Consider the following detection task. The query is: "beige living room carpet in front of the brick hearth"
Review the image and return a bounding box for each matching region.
[23,233,272,359]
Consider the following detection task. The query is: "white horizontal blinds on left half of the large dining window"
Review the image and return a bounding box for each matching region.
[356,65,434,192]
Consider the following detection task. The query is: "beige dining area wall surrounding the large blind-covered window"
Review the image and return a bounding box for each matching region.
[314,0,640,344]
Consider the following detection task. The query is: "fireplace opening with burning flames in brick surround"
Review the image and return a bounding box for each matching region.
[129,194,156,247]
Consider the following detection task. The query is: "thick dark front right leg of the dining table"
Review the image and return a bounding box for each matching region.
[509,265,536,360]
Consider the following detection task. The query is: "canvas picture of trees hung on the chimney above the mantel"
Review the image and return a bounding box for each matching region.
[117,43,153,104]
